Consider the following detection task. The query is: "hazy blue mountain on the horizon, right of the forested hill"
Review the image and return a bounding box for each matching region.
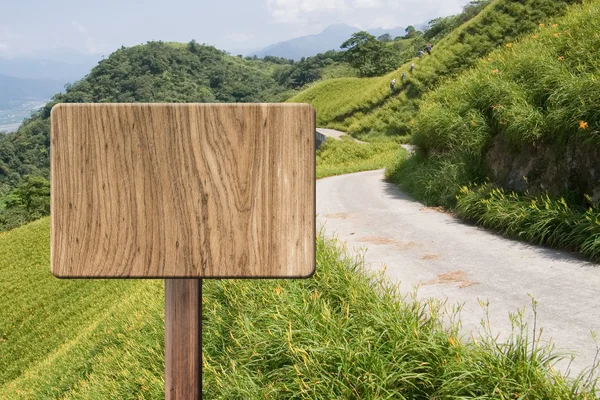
[248,24,406,60]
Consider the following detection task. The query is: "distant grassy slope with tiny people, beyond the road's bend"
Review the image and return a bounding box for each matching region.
[289,0,578,134]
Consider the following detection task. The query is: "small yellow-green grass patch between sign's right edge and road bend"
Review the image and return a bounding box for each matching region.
[317,137,406,179]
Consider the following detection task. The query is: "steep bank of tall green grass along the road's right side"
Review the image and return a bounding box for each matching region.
[389,1,600,260]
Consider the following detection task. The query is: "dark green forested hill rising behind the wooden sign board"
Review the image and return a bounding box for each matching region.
[0,41,290,230]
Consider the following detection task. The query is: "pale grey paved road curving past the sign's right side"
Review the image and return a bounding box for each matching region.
[317,170,600,378]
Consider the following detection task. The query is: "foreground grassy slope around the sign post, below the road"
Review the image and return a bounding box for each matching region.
[0,218,595,400]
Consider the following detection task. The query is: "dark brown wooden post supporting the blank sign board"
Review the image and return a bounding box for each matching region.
[165,279,202,400]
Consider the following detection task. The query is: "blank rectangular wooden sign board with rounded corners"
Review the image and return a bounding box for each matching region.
[50,104,315,278]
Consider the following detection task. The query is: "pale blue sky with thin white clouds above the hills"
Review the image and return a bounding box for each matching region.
[0,0,468,57]
